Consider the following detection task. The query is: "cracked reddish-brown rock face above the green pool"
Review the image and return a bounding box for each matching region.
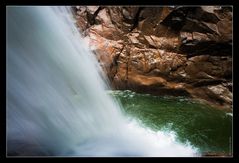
[73,6,232,108]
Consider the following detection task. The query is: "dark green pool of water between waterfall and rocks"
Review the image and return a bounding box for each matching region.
[110,90,232,155]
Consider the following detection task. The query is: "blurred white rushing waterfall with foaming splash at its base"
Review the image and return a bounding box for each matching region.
[7,7,197,156]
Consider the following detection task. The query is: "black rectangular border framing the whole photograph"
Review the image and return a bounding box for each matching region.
[0,0,239,161]
